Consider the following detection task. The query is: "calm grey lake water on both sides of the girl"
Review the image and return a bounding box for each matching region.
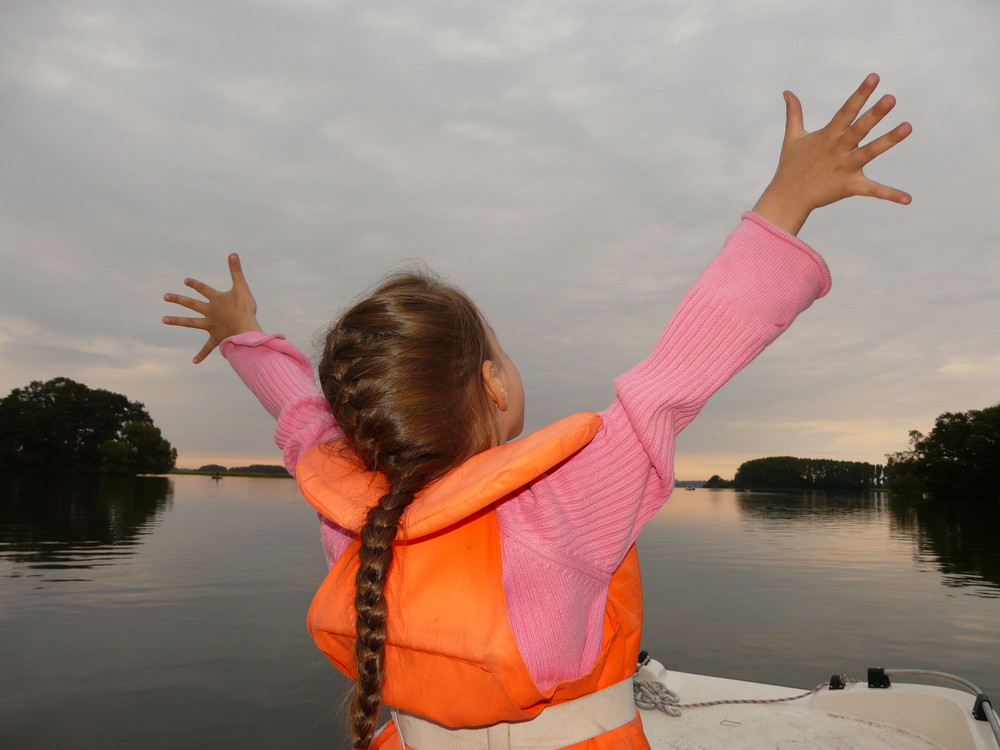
[0,476,1000,750]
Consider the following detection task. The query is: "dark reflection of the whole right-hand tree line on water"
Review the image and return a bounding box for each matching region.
[736,491,1000,597]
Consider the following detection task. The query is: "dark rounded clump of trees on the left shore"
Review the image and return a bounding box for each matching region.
[0,378,177,474]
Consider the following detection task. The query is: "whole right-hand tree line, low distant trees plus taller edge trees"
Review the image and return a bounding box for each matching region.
[705,404,1000,501]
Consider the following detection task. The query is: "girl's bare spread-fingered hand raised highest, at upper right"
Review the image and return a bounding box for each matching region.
[754,73,913,234]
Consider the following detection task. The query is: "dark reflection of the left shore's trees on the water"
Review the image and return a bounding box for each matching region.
[0,475,173,568]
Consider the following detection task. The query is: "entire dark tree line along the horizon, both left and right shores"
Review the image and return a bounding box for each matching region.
[0,378,1000,500]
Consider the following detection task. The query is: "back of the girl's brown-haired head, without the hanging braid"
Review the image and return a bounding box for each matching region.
[319,271,494,481]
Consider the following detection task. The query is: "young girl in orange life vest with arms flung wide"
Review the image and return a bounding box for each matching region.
[164,74,910,750]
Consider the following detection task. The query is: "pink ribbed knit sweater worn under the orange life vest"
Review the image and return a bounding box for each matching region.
[221,213,830,690]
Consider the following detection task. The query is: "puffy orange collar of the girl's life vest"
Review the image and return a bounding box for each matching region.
[295,412,601,539]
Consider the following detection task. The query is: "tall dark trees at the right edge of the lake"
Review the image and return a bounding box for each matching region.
[886,404,1000,500]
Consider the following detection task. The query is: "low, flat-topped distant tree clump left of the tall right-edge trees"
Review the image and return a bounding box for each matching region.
[734,456,882,490]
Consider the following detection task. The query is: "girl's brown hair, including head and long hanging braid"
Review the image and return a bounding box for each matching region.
[319,272,497,748]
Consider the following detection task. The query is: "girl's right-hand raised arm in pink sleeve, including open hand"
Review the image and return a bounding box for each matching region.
[505,74,911,575]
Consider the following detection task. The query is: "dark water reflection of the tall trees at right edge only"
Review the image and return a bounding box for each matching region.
[889,497,1000,588]
